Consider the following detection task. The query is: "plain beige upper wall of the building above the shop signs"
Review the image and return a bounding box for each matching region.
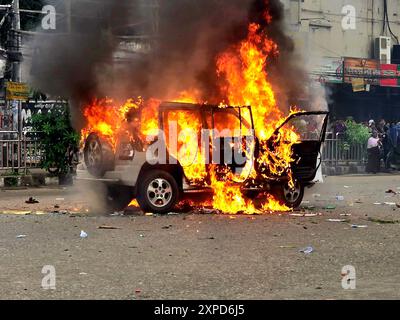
[281,0,400,59]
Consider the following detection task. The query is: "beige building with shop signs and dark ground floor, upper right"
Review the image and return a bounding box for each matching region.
[282,0,400,121]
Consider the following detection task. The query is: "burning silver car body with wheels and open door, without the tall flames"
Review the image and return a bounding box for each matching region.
[80,101,327,214]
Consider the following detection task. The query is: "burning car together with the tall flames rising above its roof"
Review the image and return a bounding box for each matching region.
[74,5,328,214]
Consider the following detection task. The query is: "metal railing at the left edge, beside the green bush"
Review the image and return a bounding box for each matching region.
[0,131,43,175]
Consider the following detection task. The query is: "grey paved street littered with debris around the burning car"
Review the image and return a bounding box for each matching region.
[0,175,400,299]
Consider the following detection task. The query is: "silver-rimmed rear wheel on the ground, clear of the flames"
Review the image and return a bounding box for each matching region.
[137,170,179,214]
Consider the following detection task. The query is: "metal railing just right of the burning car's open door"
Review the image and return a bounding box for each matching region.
[322,132,367,166]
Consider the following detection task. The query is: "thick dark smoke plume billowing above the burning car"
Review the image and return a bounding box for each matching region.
[31,0,312,126]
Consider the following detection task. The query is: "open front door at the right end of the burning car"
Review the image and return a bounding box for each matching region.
[276,111,329,184]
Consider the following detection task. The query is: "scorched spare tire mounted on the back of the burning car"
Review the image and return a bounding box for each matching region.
[84,133,115,178]
